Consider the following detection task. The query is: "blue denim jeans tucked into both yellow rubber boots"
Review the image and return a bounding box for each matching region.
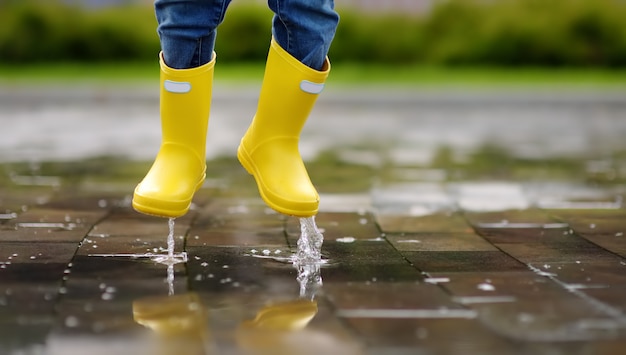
[154,0,339,70]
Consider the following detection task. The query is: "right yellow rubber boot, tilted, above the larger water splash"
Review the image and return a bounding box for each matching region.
[237,39,330,217]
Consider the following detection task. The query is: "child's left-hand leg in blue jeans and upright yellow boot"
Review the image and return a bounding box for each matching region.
[133,0,229,217]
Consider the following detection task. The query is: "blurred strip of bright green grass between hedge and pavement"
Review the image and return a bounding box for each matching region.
[0,61,626,89]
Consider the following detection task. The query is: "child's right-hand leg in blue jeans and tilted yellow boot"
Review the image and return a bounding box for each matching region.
[237,0,339,217]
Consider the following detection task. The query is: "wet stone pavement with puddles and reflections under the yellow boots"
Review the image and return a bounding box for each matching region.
[0,82,626,354]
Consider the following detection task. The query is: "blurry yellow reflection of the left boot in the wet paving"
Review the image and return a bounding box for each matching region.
[133,293,208,355]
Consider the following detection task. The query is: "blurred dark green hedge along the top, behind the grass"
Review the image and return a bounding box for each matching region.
[0,0,626,67]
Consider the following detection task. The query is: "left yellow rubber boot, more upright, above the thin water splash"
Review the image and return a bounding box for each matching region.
[133,54,215,218]
